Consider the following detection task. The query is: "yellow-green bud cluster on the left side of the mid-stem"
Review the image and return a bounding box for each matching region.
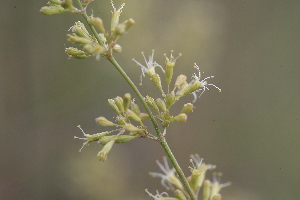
[74,93,156,161]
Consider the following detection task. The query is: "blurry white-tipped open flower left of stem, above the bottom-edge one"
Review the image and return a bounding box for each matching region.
[149,157,184,191]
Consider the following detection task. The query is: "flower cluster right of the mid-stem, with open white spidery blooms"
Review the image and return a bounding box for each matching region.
[133,50,221,128]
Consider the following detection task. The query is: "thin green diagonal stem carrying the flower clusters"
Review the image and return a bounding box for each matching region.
[76,0,196,200]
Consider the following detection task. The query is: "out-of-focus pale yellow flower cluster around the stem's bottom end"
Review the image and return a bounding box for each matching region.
[146,154,231,200]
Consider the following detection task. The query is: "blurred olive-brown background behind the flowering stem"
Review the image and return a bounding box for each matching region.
[0,0,300,200]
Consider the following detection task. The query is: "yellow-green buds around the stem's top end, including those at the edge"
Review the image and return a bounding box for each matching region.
[41,0,135,60]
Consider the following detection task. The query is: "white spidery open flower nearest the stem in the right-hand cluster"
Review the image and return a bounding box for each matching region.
[132,50,165,85]
